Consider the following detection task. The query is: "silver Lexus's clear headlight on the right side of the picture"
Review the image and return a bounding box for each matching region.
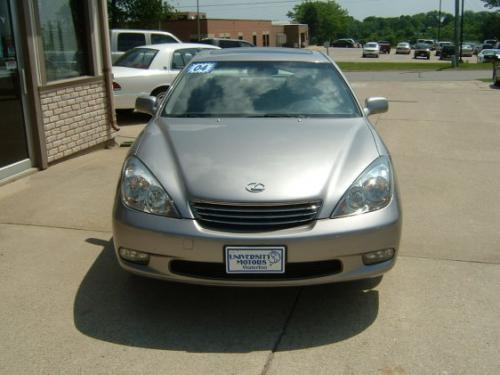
[332,156,394,218]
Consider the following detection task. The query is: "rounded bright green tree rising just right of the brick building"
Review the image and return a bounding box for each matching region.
[287,0,352,44]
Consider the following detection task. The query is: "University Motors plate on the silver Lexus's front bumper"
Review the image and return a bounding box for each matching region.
[225,246,285,273]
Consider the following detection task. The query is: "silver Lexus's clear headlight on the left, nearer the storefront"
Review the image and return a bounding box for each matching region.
[121,157,179,218]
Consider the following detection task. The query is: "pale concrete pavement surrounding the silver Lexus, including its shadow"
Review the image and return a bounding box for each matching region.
[0,80,500,374]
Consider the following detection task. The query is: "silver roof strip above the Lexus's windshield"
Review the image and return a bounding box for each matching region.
[189,47,330,62]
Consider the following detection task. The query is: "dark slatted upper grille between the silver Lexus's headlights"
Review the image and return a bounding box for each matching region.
[191,201,321,232]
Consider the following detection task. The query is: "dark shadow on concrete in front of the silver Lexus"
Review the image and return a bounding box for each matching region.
[73,238,379,353]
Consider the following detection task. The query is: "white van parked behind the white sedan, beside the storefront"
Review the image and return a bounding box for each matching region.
[110,29,181,62]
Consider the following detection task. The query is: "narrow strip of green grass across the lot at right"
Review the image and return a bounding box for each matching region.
[337,61,492,72]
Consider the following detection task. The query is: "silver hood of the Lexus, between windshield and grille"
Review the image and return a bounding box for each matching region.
[135,117,379,214]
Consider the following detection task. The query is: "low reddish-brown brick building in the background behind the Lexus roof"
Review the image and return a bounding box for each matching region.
[162,17,309,47]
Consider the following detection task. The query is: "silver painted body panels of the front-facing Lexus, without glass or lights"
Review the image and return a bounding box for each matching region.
[113,48,402,286]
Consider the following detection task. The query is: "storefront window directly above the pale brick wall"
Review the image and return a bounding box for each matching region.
[37,0,92,82]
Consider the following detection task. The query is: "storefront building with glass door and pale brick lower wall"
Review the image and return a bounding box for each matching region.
[0,0,116,181]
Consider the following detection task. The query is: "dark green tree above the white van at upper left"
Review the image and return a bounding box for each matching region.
[108,0,175,29]
